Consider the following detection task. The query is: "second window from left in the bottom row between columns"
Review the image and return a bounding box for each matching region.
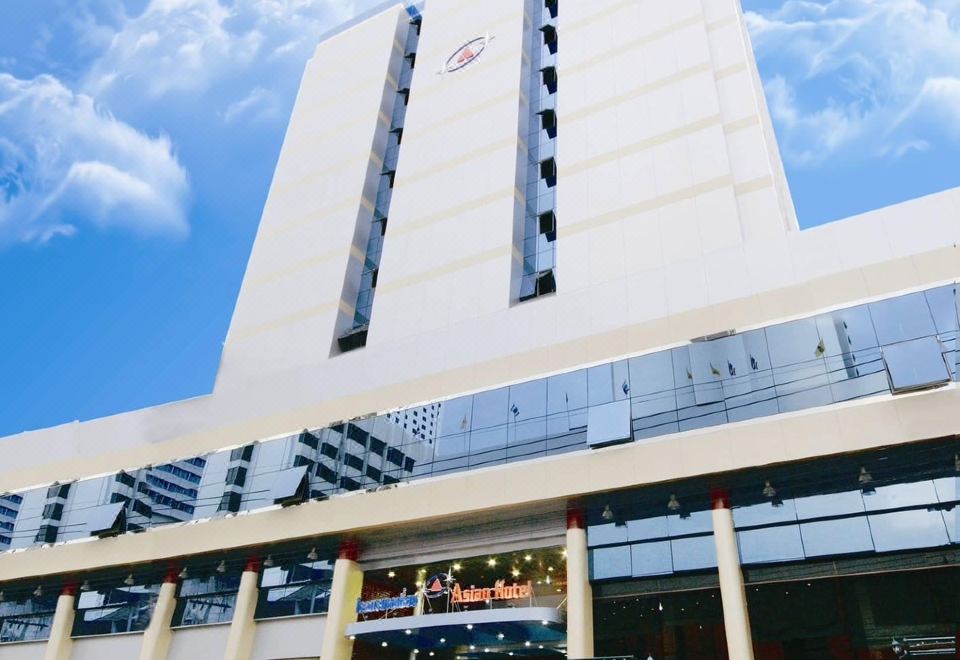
[73,585,160,637]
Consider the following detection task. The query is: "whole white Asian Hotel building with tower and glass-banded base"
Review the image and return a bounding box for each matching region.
[0,0,960,660]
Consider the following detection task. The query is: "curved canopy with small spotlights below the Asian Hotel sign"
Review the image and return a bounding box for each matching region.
[347,607,567,653]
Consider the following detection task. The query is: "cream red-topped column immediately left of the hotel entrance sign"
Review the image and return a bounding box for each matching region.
[320,541,363,660]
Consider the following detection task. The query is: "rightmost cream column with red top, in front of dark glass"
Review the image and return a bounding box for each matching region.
[713,491,753,660]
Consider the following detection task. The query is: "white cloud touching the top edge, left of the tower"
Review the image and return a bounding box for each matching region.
[84,0,374,109]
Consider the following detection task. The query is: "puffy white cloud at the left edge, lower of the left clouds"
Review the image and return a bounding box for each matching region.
[0,74,189,244]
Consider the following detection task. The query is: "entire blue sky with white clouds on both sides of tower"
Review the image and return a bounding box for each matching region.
[0,0,960,436]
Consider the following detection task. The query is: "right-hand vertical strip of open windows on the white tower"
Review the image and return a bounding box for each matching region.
[520,0,558,302]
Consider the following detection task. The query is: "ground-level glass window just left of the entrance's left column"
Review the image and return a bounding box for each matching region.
[256,561,333,619]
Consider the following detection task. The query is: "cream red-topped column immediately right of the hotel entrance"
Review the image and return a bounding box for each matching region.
[567,509,593,659]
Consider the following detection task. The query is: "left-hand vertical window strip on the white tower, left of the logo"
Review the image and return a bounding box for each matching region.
[338,5,423,351]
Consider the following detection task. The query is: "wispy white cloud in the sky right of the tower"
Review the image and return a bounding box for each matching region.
[746,0,960,165]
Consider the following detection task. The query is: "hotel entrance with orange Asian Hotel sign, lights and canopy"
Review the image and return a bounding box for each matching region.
[347,547,566,660]
